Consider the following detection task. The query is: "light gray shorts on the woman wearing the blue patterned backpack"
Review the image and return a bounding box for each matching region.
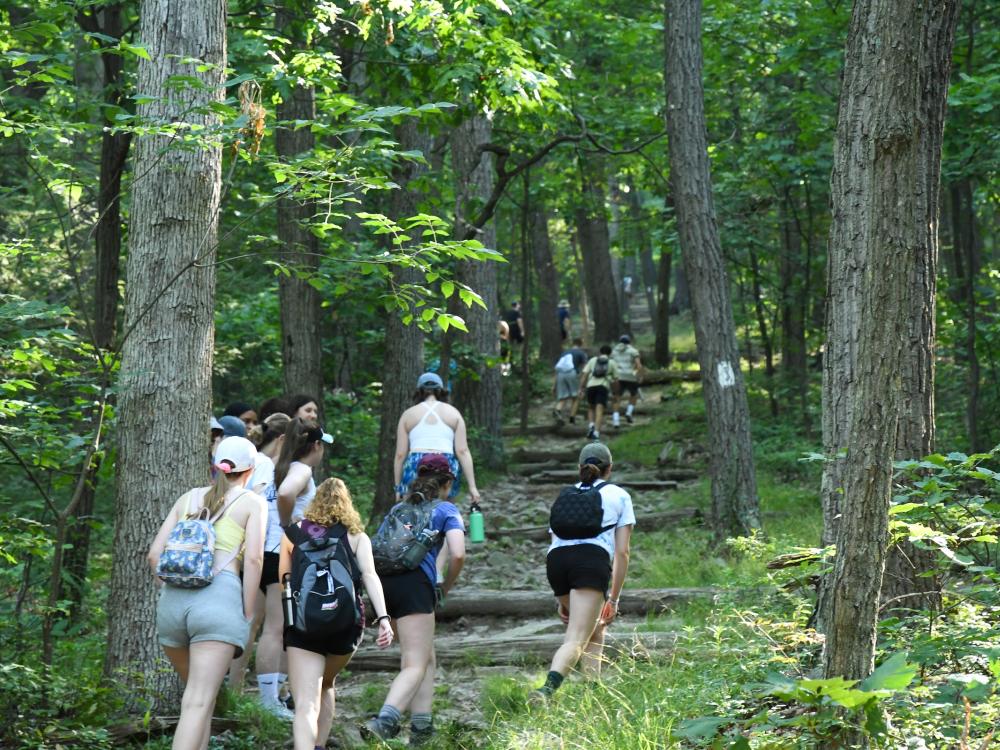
[156,570,250,656]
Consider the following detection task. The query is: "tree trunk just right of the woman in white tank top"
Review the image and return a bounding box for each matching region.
[451,115,503,469]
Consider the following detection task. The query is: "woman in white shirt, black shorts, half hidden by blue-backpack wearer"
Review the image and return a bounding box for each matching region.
[229,412,292,720]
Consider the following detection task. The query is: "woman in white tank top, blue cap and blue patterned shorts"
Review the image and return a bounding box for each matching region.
[393,372,480,503]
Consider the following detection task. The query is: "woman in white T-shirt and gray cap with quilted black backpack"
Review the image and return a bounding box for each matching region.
[529,443,635,703]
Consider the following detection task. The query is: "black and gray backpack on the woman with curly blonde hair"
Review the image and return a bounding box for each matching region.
[285,524,365,637]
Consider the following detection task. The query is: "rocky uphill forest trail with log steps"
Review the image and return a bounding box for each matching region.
[335,306,715,745]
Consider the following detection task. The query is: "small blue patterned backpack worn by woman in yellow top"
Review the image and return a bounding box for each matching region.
[156,492,247,589]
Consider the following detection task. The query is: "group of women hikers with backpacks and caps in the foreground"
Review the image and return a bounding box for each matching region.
[148,372,635,750]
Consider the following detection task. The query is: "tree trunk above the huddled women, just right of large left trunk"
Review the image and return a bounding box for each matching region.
[274,8,323,406]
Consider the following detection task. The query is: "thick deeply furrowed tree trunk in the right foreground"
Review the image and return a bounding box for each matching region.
[820,0,956,720]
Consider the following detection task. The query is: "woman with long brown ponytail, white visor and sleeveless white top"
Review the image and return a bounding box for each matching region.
[274,424,333,527]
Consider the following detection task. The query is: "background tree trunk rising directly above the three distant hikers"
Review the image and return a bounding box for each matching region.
[576,156,622,344]
